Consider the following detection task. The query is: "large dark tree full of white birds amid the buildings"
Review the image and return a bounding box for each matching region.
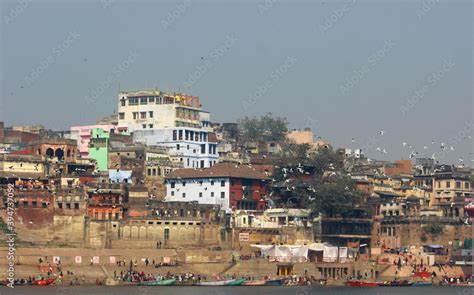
[273,144,362,216]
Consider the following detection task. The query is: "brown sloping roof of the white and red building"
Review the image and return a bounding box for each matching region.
[166,163,267,179]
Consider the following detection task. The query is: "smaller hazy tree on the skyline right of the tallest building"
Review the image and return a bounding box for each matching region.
[238,113,288,142]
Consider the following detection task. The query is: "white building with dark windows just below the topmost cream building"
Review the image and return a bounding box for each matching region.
[133,127,219,168]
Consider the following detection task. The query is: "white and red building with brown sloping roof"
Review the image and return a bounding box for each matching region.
[165,163,267,210]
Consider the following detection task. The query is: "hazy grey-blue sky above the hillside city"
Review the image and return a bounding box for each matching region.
[0,0,474,166]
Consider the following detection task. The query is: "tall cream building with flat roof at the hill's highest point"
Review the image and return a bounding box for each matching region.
[118,89,210,131]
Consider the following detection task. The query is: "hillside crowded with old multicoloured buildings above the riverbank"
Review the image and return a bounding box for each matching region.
[0,89,474,279]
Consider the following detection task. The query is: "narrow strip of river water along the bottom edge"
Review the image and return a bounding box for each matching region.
[0,286,474,295]
